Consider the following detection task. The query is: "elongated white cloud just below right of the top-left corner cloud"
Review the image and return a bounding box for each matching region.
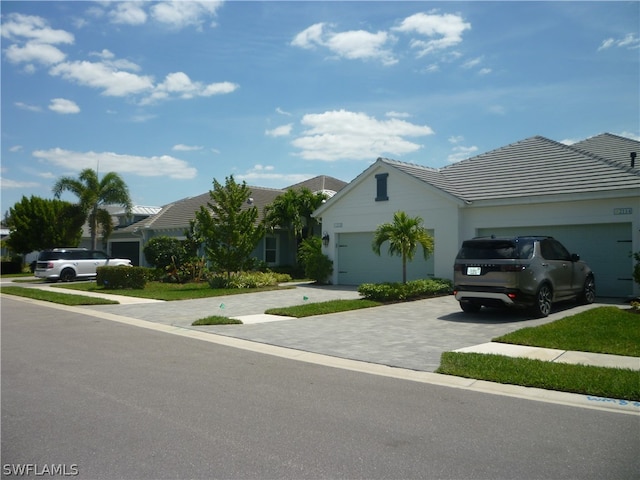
[49,61,153,97]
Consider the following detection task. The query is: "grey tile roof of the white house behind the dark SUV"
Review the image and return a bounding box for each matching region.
[379,135,640,202]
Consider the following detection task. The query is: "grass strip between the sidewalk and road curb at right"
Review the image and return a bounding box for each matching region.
[436,352,640,401]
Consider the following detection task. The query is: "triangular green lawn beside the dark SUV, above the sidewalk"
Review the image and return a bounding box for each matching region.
[493,307,640,357]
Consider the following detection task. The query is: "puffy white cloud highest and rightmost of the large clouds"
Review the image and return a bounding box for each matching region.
[393,12,471,57]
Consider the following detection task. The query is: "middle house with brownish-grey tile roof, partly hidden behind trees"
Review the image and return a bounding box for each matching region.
[109,175,347,266]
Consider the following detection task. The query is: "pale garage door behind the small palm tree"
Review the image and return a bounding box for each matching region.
[334,231,434,285]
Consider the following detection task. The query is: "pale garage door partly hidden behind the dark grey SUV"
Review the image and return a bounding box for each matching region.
[478,223,633,297]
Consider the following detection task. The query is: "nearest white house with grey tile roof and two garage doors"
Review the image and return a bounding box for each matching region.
[314,133,640,297]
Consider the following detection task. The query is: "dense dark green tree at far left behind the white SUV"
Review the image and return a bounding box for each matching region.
[6,196,84,254]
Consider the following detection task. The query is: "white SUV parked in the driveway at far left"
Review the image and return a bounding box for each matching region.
[33,248,131,282]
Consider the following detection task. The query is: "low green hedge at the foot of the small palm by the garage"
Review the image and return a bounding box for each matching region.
[358,278,453,302]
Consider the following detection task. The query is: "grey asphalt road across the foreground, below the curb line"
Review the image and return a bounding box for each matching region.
[1,296,640,480]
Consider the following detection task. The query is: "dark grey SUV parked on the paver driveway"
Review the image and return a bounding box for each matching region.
[453,236,596,317]
